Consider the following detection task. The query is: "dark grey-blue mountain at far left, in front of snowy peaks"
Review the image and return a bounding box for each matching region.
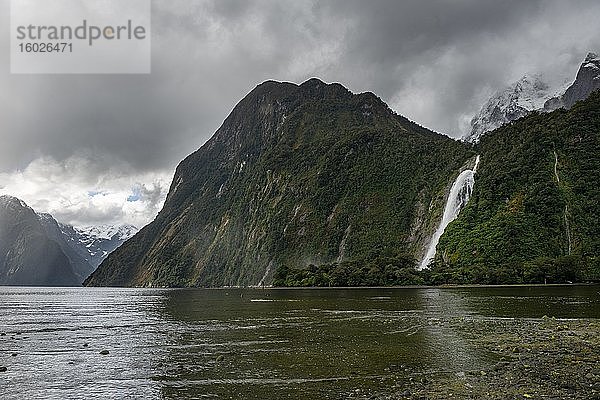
[0,196,81,286]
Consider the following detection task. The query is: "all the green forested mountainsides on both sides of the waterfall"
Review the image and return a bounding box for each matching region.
[86,79,600,286]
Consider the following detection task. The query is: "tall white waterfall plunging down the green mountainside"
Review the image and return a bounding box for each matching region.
[419,156,479,270]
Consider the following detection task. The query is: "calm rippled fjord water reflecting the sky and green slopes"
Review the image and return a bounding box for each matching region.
[0,286,600,399]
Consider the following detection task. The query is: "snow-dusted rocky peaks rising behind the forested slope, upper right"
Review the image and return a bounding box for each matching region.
[464,53,600,143]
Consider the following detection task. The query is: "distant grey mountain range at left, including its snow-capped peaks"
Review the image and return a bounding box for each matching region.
[0,196,137,286]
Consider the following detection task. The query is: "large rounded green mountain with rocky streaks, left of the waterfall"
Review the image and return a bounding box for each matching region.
[85,79,475,287]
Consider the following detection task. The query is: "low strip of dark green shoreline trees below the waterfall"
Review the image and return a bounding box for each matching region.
[273,256,600,287]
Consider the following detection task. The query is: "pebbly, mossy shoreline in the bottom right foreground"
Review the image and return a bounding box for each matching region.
[372,317,600,400]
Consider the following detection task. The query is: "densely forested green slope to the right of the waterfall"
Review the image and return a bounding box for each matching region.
[434,91,600,283]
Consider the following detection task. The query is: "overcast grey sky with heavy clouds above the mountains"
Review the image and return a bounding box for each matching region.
[0,0,600,227]
